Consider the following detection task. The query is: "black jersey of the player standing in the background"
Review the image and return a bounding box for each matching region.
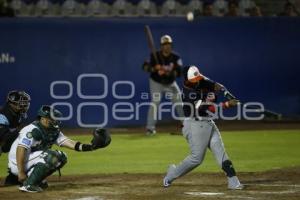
[150,51,182,85]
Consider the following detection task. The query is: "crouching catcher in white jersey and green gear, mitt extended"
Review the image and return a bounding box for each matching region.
[8,105,111,192]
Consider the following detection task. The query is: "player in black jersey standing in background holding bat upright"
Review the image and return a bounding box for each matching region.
[143,35,183,135]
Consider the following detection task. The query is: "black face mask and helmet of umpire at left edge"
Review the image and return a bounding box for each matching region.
[6,90,31,113]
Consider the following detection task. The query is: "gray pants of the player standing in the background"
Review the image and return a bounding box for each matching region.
[146,78,184,130]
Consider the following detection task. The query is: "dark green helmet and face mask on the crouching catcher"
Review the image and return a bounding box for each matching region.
[38,105,62,129]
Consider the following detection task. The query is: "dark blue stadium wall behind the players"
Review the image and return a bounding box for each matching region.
[0,17,300,126]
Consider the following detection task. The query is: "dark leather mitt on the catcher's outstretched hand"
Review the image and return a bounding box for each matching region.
[91,128,111,149]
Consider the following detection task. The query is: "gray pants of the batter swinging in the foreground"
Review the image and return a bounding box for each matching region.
[166,119,229,181]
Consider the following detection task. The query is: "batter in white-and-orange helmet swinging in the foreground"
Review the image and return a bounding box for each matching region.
[163,66,243,189]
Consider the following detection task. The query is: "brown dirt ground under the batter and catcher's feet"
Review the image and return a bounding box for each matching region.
[0,167,300,200]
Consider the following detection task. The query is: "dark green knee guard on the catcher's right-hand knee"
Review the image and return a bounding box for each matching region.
[44,150,67,170]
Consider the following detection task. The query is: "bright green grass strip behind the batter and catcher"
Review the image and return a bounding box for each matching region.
[0,130,300,177]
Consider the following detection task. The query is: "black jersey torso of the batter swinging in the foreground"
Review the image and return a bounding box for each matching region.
[182,78,216,118]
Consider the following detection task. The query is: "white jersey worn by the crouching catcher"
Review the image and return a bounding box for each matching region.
[9,124,68,163]
